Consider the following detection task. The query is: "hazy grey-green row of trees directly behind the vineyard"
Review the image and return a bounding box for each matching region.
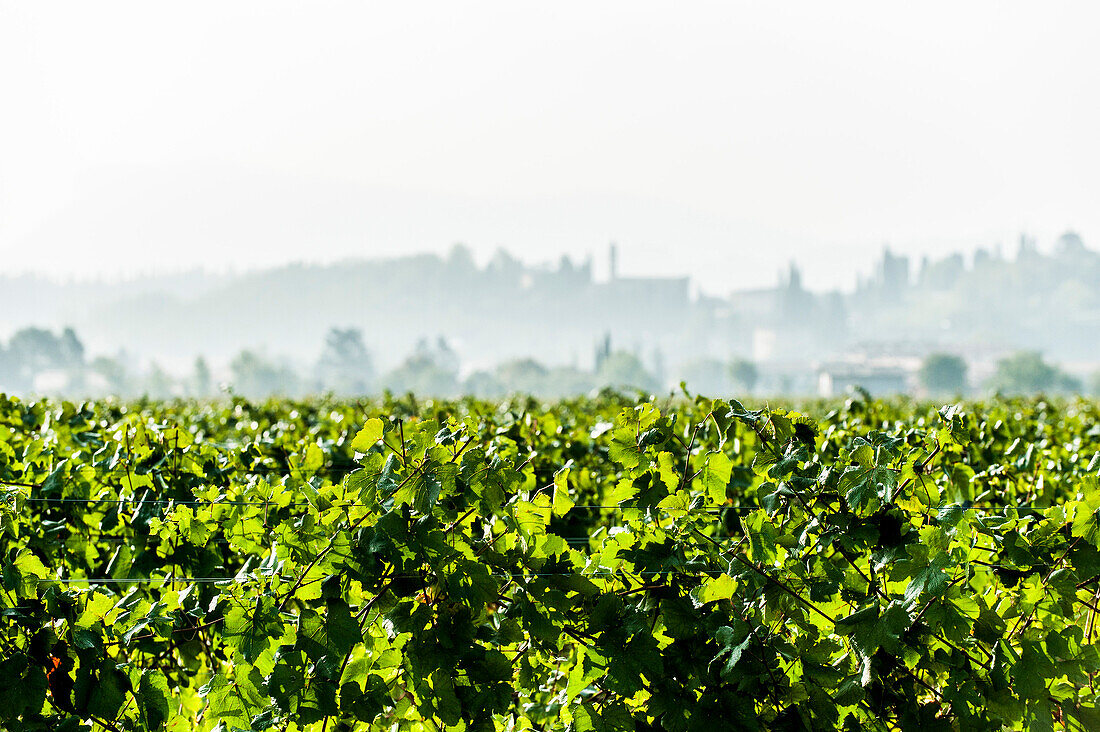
[0,327,1100,398]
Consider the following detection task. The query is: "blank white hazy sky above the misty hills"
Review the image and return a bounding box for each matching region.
[0,0,1100,292]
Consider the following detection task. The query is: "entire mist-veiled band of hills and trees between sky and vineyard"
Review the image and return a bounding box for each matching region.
[0,231,1100,397]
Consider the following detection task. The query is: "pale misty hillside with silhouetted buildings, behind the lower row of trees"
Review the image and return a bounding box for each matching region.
[0,232,1100,385]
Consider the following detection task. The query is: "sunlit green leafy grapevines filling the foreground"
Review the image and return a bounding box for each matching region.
[0,393,1100,732]
